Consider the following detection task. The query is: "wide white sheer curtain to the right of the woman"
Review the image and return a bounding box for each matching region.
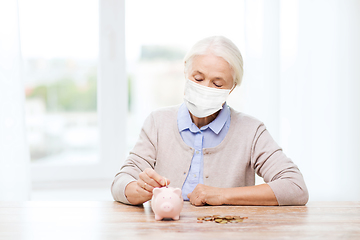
[243,0,360,201]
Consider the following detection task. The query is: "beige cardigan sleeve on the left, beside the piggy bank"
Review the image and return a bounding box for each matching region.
[111,114,157,204]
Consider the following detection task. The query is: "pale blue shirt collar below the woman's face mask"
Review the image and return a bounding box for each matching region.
[177,102,230,134]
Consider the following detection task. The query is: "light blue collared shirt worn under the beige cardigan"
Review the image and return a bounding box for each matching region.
[177,103,230,200]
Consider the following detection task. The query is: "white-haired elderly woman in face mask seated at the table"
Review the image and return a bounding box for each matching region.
[111,36,308,205]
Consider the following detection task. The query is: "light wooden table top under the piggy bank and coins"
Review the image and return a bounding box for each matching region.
[0,202,360,240]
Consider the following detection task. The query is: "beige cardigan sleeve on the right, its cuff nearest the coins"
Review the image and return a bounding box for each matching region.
[251,124,309,205]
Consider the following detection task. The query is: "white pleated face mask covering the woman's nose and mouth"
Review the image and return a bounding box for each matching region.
[184,80,231,118]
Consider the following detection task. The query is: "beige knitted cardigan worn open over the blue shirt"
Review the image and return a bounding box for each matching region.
[111,106,308,205]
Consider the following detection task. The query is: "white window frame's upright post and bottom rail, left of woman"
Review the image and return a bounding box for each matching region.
[30,0,128,187]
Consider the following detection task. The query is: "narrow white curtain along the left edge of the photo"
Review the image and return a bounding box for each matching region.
[0,0,30,201]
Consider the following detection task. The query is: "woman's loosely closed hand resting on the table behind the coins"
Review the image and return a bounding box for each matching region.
[187,184,224,206]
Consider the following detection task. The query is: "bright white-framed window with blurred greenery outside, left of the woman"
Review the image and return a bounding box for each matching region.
[19,0,127,182]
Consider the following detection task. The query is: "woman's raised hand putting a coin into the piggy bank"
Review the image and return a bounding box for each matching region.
[125,168,170,205]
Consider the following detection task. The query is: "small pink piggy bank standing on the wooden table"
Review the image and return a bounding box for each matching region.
[151,187,184,220]
